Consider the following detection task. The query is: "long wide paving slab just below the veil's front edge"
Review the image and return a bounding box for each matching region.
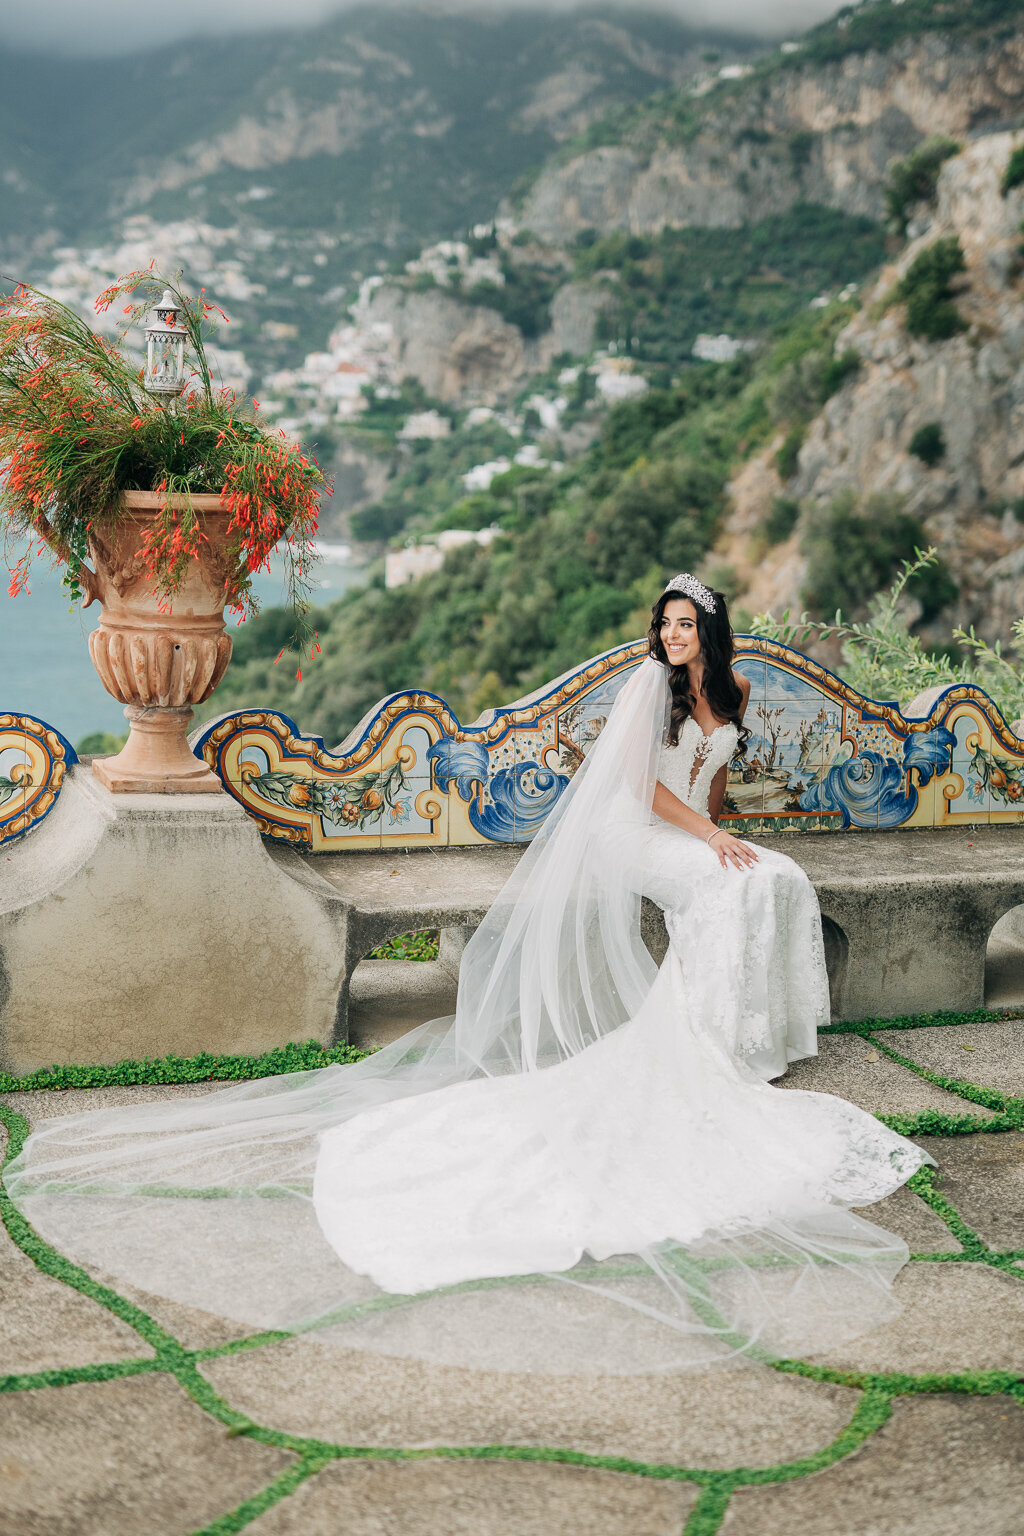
[201,1339,857,1467]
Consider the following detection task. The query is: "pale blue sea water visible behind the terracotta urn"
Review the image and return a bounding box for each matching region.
[0,544,364,743]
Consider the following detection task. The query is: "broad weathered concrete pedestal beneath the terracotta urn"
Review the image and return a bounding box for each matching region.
[0,759,345,1074]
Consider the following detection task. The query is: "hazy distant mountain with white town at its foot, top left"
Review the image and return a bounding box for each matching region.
[0,6,754,372]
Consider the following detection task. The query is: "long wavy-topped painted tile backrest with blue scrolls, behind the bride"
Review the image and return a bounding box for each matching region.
[191,637,1024,849]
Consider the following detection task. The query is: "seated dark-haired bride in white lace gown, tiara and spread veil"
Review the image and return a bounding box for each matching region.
[8,574,927,1373]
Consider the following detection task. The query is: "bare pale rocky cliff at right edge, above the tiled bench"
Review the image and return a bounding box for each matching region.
[720,131,1024,639]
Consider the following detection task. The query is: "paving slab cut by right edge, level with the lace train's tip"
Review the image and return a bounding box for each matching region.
[915,1130,1024,1249]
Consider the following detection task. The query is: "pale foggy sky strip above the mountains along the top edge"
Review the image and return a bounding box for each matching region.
[0,0,841,55]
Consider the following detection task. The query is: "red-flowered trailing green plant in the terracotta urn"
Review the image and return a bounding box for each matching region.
[0,269,327,663]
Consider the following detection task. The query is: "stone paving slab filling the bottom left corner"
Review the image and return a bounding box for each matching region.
[0,1375,293,1536]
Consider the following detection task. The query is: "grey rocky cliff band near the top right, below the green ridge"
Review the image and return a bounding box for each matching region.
[516,31,1024,244]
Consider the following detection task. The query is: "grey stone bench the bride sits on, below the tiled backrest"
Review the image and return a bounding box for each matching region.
[280,826,1024,1038]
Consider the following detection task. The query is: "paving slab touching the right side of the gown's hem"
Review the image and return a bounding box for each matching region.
[777,1029,989,1118]
